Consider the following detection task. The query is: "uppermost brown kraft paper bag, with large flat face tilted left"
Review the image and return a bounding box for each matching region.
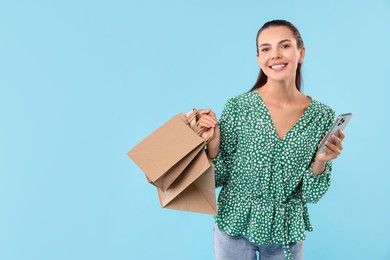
[128,111,205,190]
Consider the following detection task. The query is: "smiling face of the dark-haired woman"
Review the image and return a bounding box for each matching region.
[256,26,305,82]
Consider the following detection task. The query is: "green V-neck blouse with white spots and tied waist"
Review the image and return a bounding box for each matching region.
[212,90,335,259]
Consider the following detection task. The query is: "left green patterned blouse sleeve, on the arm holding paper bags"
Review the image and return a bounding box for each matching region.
[211,99,237,188]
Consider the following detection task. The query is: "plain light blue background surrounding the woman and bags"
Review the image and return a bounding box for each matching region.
[0,0,390,260]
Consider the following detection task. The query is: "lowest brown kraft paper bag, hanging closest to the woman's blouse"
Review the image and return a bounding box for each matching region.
[157,150,217,215]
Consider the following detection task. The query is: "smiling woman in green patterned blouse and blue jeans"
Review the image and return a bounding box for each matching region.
[198,20,345,260]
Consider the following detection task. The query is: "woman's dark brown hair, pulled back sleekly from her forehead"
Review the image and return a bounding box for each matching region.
[250,20,303,91]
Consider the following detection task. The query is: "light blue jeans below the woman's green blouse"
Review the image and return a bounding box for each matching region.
[214,224,303,260]
